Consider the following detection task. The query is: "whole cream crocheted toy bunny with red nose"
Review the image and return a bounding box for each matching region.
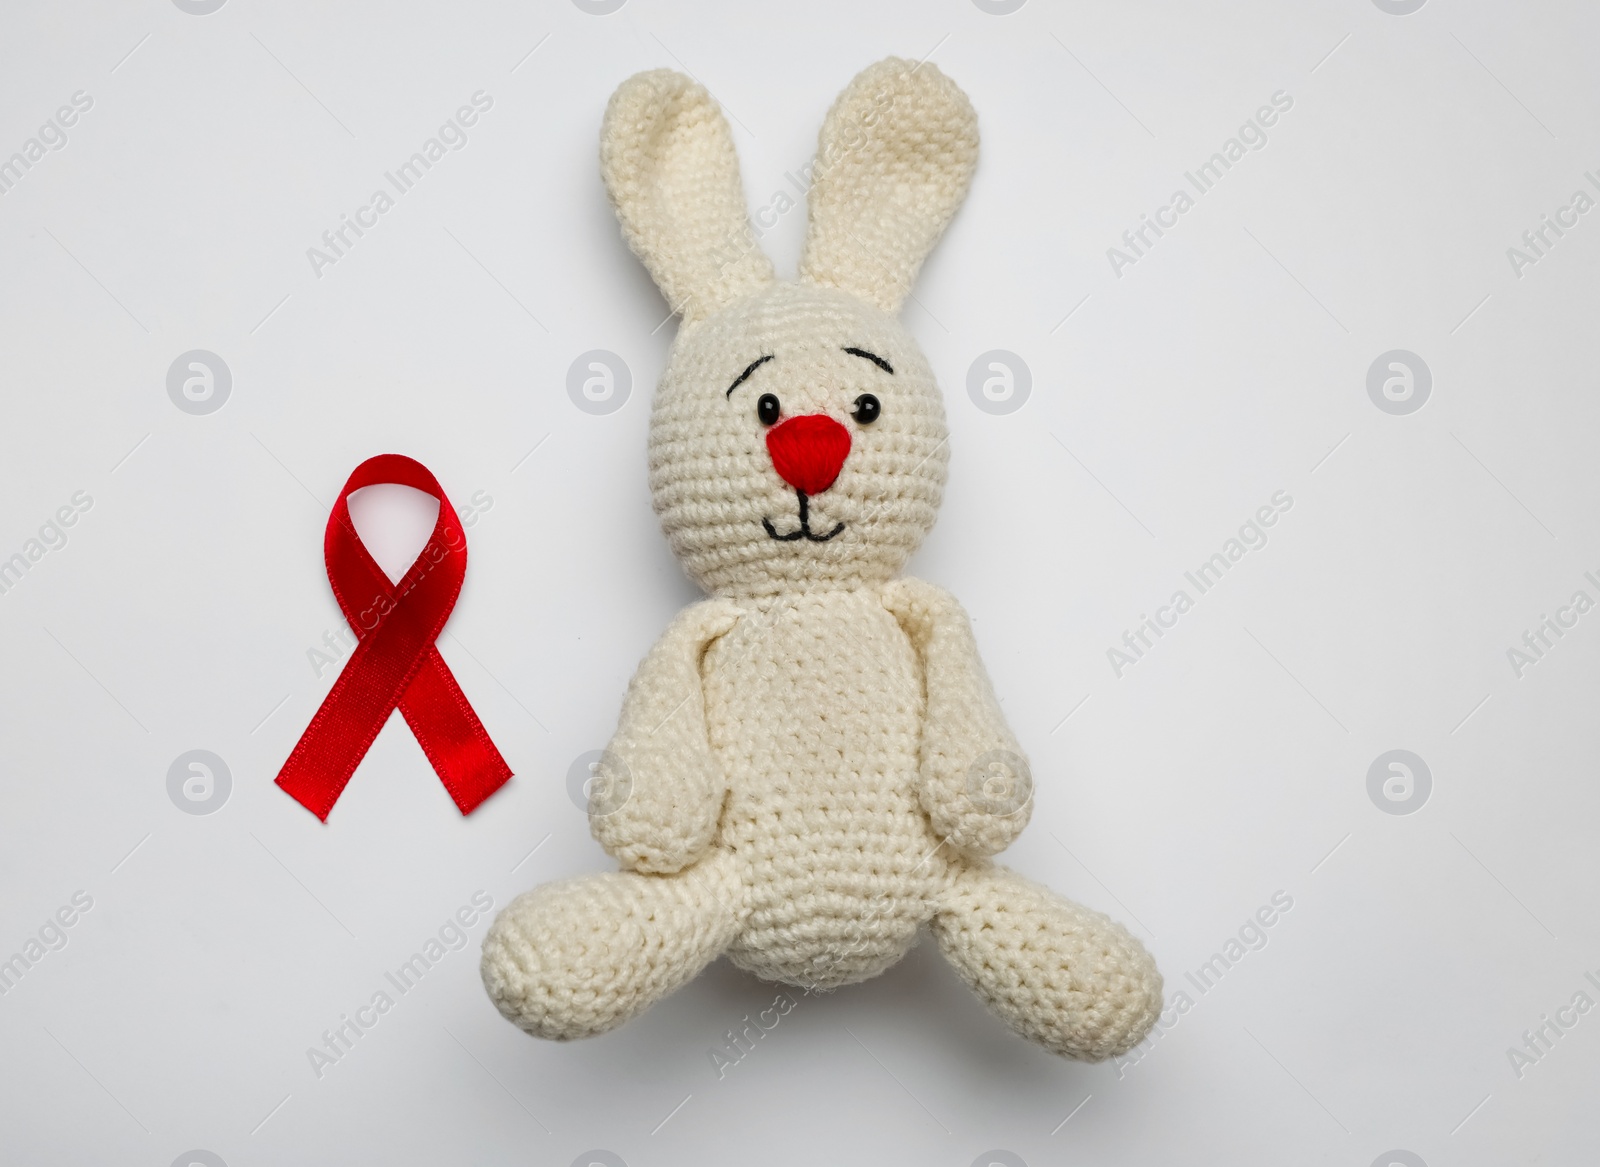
[483,58,1162,1061]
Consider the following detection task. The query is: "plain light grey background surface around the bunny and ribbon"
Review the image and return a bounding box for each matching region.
[0,0,1600,1167]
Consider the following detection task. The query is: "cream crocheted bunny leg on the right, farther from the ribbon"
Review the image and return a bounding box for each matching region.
[933,861,1162,1061]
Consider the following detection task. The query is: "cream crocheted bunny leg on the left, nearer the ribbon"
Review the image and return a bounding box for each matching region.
[482,848,742,1041]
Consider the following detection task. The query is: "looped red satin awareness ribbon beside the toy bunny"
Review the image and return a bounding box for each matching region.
[278,455,510,823]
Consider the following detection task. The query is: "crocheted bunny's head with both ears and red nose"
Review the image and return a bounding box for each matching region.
[600,58,978,597]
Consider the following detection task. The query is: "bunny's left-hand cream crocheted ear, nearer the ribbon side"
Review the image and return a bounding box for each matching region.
[600,69,773,322]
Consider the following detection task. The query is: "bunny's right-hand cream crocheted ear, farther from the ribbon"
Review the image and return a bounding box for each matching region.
[800,58,978,315]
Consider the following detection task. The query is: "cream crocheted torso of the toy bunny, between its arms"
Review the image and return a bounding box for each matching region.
[706,588,947,988]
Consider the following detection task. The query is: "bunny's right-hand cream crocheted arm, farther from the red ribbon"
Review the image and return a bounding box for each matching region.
[883,578,1034,855]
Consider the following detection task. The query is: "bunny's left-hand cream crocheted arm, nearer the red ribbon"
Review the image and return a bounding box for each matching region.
[589,600,739,872]
